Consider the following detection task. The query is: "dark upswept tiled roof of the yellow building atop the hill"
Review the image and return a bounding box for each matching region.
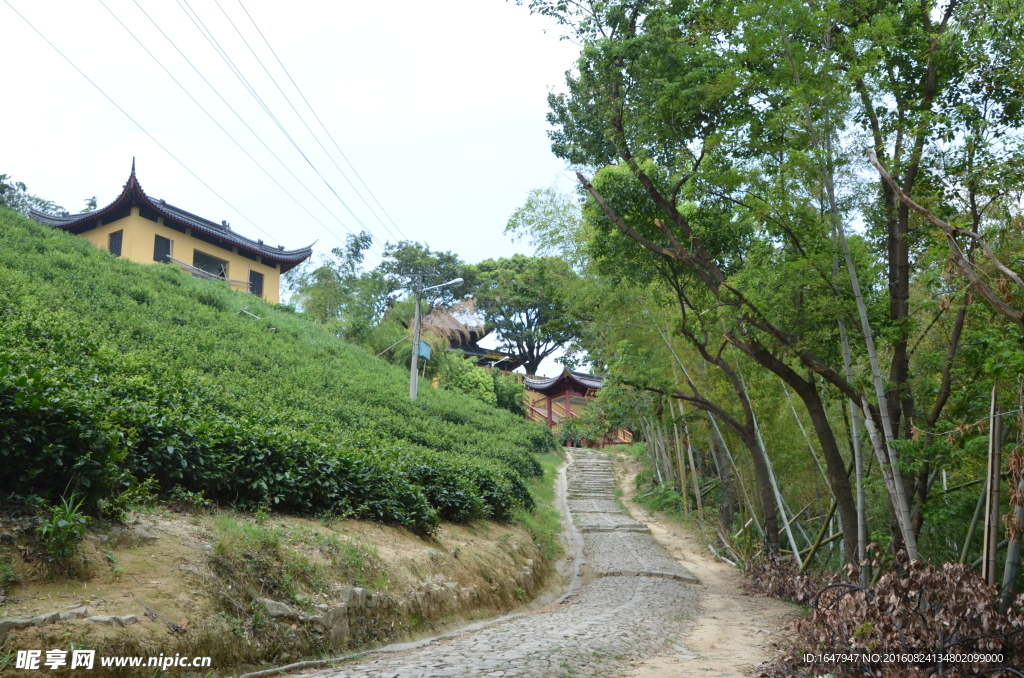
[30,163,312,272]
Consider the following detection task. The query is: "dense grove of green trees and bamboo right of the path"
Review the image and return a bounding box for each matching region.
[508,0,1024,607]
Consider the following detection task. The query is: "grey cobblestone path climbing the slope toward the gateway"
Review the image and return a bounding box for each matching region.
[314,450,699,678]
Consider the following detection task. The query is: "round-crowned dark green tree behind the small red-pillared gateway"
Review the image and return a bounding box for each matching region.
[473,254,577,374]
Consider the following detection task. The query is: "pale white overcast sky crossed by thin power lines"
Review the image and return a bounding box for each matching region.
[0,0,578,372]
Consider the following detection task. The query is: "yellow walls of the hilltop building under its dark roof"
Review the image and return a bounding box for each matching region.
[75,207,281,303]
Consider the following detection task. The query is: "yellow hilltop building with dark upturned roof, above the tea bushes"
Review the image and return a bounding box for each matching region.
[31,162,312,303]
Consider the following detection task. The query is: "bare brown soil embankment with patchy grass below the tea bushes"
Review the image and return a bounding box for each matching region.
[0,509,552,676]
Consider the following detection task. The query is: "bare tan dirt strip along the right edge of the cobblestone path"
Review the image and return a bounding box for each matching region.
[614,457,799,678]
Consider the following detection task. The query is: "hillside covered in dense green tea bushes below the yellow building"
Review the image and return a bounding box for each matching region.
[0,208,554,533]
